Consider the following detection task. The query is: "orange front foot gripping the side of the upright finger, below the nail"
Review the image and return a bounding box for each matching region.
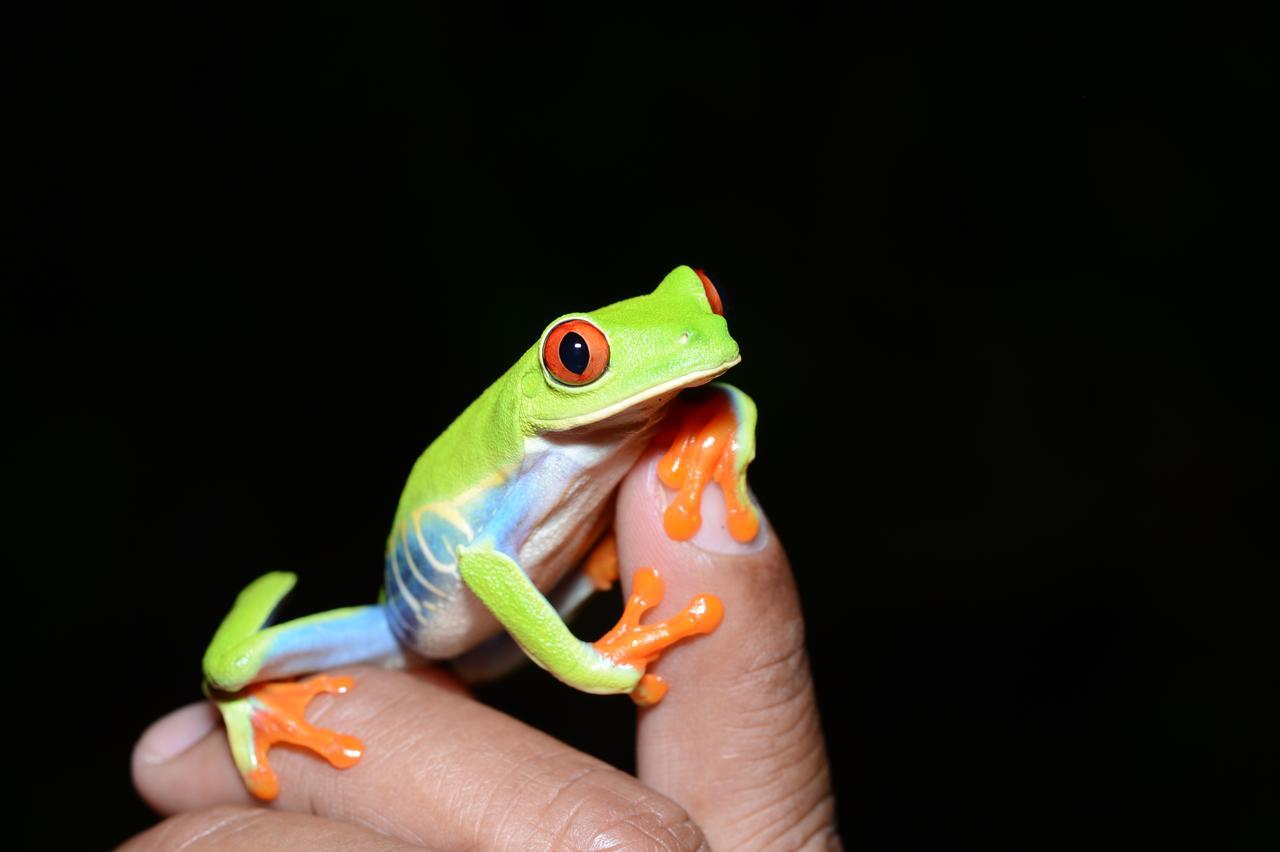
[593,568,724,706]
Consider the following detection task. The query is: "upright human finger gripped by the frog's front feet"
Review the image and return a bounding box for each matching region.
[617,453,837,848]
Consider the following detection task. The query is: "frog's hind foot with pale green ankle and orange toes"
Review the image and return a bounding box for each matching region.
[212,674,365,800]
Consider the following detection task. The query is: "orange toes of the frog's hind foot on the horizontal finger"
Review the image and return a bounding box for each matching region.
[244,674,365,800]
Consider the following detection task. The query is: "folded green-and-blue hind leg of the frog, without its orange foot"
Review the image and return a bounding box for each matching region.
[204,572,399,692]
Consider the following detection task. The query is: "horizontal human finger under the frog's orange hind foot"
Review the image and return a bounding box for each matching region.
[134,668,703,849]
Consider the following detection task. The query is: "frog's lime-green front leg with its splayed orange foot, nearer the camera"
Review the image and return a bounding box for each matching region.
[458,545,724,704]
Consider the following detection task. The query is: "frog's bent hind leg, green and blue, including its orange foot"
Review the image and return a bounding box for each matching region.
[204,572,399,800]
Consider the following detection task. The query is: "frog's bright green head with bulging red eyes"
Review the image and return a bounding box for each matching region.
[521,266,741,432]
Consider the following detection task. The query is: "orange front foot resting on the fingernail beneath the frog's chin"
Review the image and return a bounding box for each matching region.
[658,393,760,541]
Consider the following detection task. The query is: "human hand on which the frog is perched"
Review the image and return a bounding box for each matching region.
[123,453,840,851]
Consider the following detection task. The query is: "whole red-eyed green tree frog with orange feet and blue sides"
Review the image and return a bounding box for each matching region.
[202,266,760,801]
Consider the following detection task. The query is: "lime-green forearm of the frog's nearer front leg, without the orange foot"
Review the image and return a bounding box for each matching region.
[458,548,643,693]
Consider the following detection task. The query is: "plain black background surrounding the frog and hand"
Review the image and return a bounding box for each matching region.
[9,3,1280,849]
